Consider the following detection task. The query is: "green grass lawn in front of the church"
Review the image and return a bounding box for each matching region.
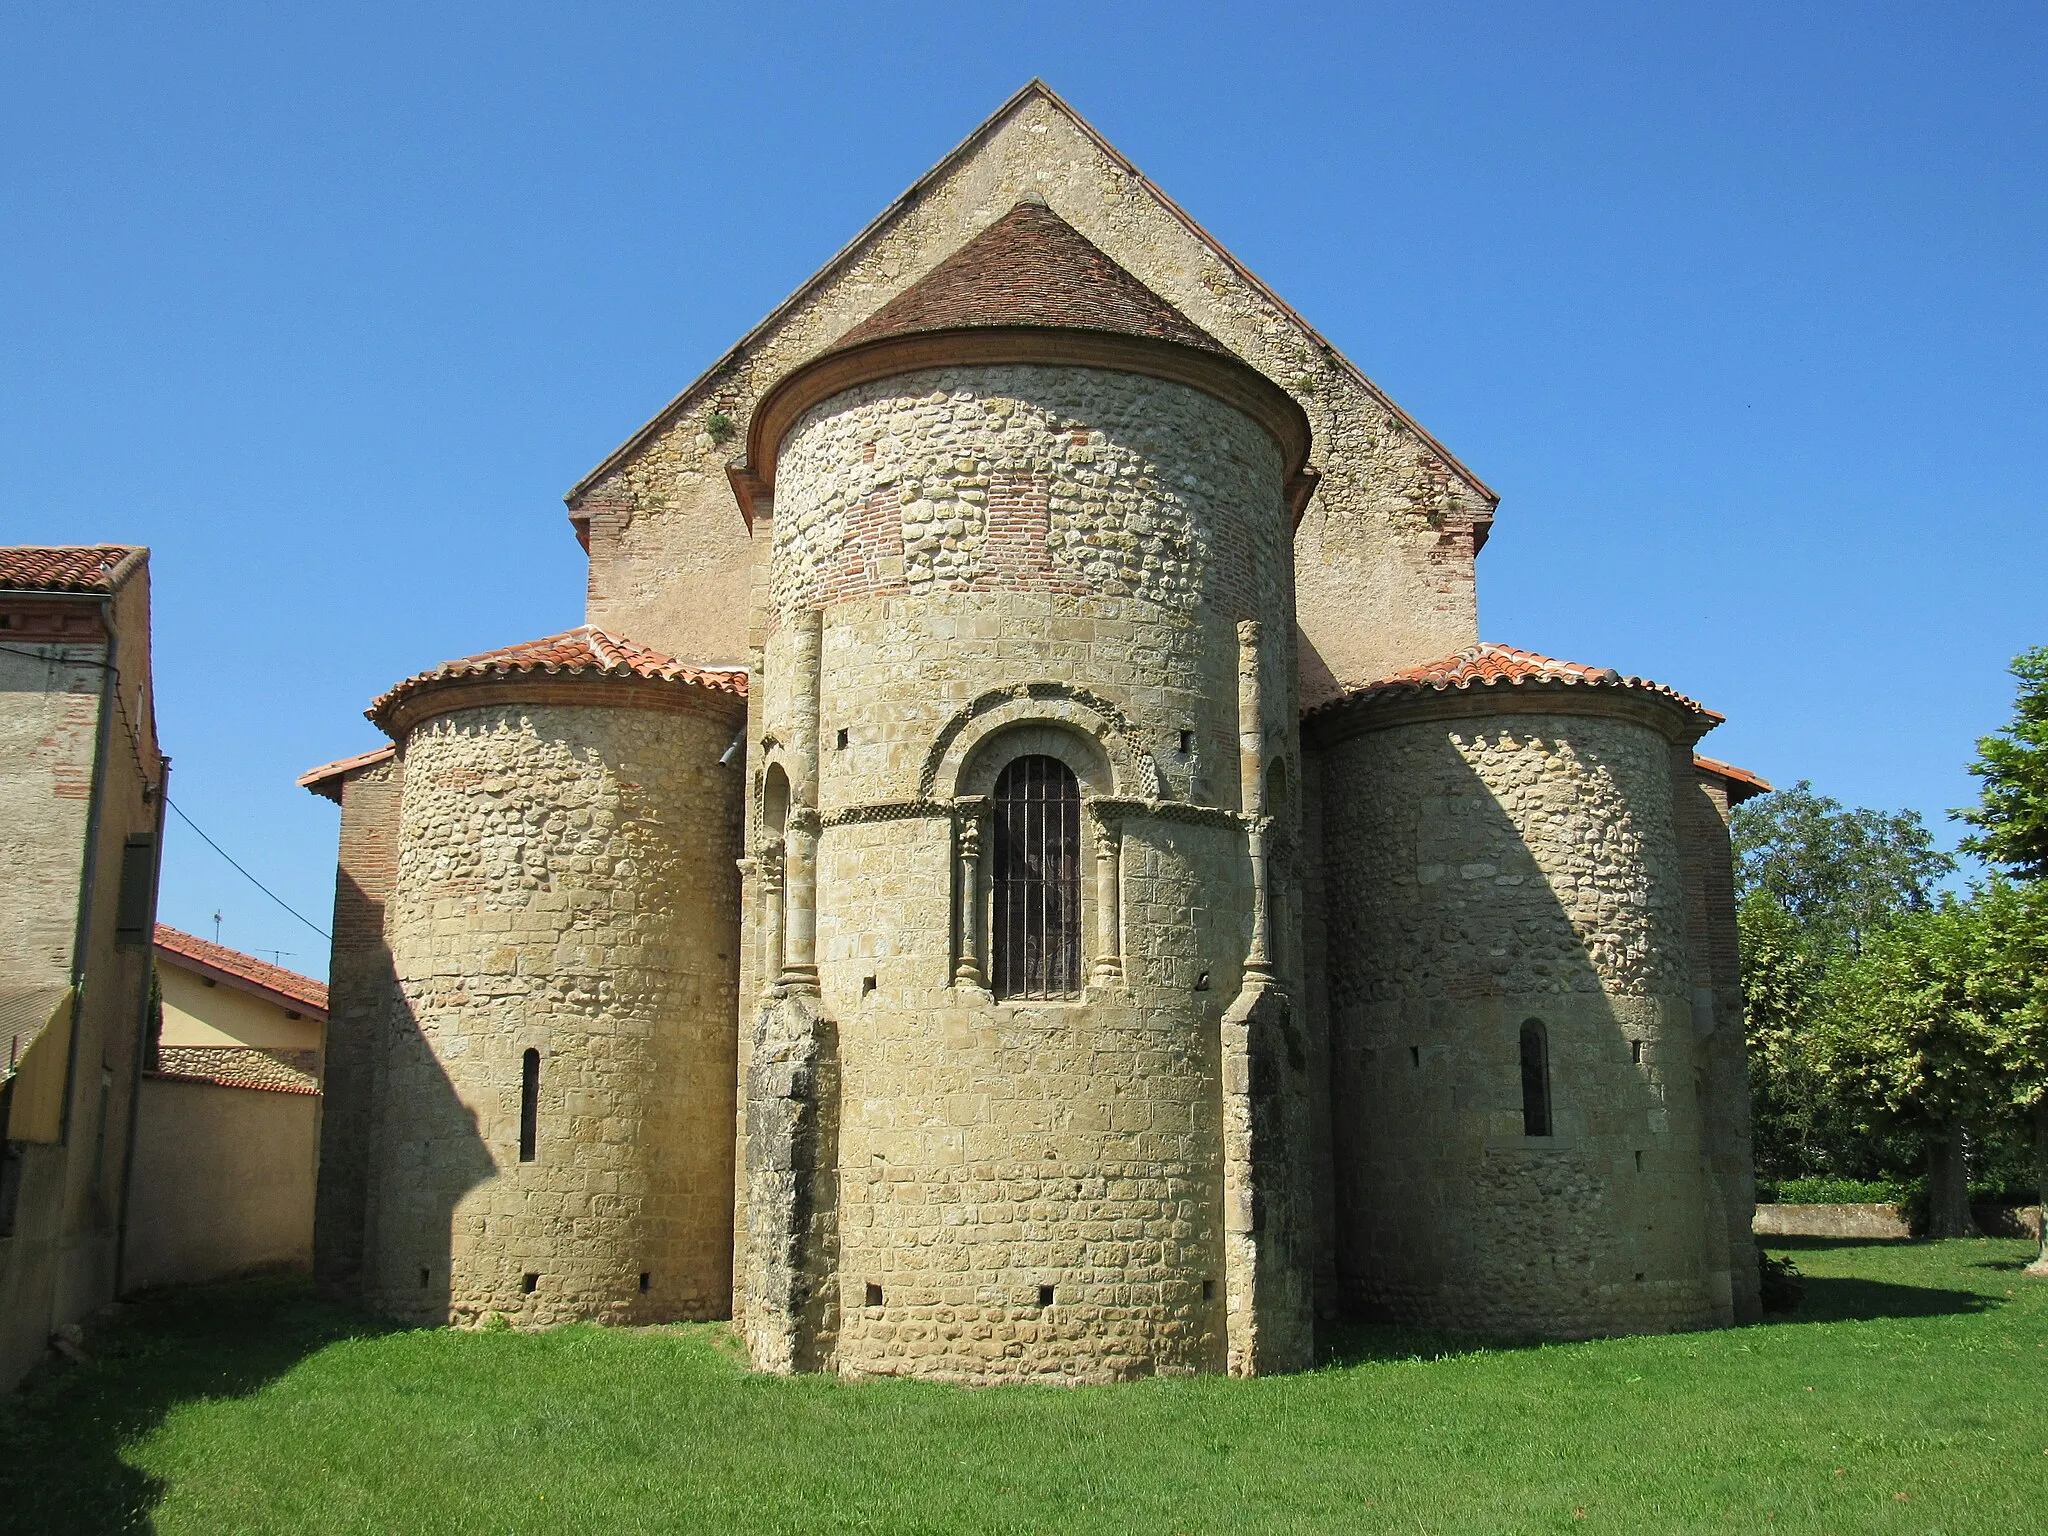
[0,1241,2048,1536]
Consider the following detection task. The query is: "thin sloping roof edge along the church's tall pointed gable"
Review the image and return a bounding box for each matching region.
[563,78,1501,508]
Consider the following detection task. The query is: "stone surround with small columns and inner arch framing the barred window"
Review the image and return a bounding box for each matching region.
[940,720,1122,991]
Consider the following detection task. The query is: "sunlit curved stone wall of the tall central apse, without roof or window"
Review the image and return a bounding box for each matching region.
[743,367,1296,1380]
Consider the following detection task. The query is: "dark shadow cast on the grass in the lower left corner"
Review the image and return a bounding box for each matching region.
[0,1276,389,1536]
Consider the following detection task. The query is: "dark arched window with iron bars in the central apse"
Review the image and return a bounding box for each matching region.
[989,756,1081,997]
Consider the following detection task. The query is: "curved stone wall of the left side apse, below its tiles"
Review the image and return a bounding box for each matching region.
[365,680,739,1323]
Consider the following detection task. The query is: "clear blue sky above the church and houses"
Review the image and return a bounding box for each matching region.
[0,0,2048,973]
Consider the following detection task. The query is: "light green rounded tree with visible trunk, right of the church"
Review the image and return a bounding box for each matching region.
[1808,897,2007,1237]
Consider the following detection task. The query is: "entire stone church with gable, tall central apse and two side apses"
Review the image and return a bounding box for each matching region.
[303,84,1759,1380]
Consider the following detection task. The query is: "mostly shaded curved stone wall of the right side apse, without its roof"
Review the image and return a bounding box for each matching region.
[1323,700,1731,1335]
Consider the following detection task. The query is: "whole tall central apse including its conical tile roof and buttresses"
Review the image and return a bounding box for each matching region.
[735,201,1309,1380]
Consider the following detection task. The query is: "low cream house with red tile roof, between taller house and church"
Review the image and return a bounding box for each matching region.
[123,926,328,1290]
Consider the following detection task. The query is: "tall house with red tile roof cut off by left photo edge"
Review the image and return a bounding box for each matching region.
[0,545,170,1391]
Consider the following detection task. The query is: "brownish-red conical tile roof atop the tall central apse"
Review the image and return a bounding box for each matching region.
[838,203,1229,354]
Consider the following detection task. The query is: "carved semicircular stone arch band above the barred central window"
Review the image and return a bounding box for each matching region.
[918,682,1159,801]
